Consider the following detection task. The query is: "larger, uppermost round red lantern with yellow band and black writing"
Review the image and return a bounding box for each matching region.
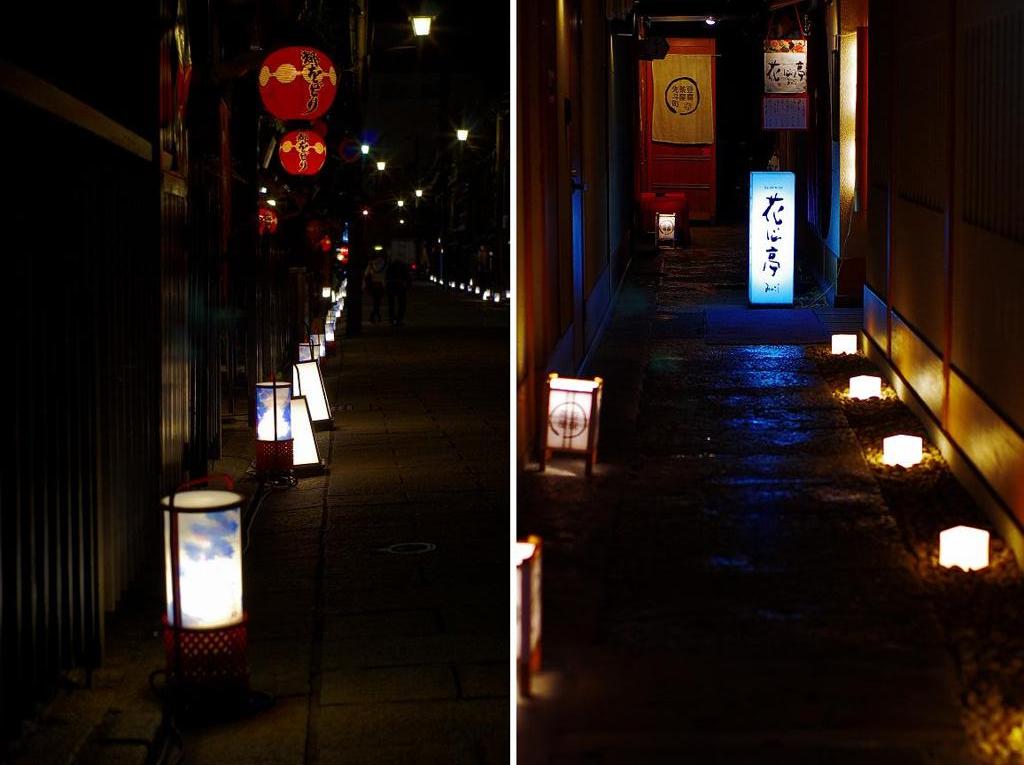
[259,46,338,121]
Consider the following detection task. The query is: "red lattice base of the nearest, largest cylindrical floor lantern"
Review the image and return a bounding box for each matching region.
[164,613,249,690]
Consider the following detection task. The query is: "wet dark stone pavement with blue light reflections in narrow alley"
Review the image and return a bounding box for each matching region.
[517,228,970,765]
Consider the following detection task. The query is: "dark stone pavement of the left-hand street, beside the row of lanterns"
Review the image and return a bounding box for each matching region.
[4,284,510,765]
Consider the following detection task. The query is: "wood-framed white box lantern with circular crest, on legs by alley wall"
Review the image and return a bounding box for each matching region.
[541,373,604,475]
